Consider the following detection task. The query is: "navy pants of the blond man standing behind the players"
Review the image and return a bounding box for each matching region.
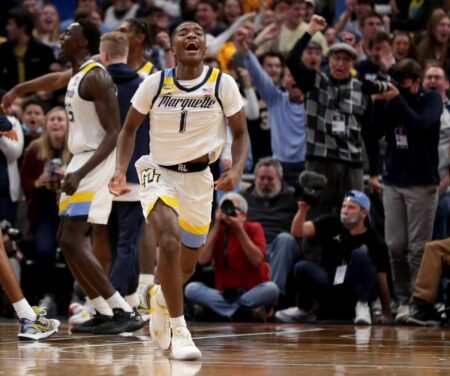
[108,201,144,296]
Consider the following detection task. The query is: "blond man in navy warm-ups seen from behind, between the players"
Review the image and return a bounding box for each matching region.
[100,32,150,307]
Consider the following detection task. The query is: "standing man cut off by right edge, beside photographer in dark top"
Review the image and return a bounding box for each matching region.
[423,64,450,240]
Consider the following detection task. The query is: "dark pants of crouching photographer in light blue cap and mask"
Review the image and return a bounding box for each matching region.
[294,249,376,310]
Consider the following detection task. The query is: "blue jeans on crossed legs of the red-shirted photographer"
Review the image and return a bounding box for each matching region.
[184,281,279,318]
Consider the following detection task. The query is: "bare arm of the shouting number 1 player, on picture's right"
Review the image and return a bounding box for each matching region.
[215,108,248,191]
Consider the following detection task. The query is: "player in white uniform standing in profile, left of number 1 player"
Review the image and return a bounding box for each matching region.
[58,20,143,334]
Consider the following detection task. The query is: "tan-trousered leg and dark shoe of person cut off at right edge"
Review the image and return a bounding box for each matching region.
[406,238,450,326]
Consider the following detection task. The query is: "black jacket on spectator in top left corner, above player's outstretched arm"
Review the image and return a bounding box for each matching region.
[0,37,55,90]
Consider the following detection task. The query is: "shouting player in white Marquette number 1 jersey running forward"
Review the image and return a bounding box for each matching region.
[110,22,248,359]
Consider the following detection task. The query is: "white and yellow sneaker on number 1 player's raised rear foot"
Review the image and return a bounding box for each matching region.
[149,285,170,350]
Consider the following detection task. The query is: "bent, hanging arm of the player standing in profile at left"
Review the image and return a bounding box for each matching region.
[62,69,120,195]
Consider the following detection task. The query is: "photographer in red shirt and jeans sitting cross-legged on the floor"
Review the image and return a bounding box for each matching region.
[185,193,279,321]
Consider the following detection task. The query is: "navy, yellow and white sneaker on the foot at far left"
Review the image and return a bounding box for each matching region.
[17,307,61,341]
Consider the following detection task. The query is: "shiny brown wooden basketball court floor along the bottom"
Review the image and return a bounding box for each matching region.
[0,323,450,376]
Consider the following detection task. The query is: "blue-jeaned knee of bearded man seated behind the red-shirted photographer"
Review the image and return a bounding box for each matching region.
[267,232,300,295]
